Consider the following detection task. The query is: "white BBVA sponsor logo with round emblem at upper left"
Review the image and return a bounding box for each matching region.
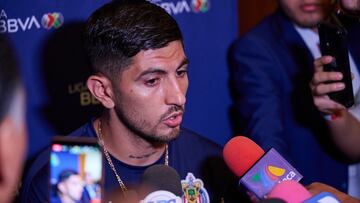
[0,9,64,33]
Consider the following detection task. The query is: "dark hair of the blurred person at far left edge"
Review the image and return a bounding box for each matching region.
[0,35,20,122]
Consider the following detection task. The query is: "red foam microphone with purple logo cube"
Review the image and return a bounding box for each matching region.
[223,136,303,199]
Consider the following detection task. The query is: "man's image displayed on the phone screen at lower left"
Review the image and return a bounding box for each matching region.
[51,170,84,203]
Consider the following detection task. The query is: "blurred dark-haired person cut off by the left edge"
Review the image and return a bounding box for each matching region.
[0,35,27,203]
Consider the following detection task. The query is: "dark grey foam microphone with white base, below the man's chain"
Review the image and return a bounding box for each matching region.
[139,165,182,203]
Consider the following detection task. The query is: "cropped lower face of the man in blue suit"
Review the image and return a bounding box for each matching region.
[279,0,332,28]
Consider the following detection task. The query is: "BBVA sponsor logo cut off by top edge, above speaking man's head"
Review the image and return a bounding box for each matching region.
[149,0,210,15]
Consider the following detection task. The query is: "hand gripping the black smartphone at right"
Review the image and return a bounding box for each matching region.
[310,56,345,114]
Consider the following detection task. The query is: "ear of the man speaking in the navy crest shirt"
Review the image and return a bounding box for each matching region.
[87,75,115,109]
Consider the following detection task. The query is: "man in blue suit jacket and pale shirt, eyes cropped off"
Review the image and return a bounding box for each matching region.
[231,0,360,195]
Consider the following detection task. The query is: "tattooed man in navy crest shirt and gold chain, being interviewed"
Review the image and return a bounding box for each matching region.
[21,0,248,202]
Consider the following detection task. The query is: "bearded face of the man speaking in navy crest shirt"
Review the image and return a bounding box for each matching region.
[113,41,189,142]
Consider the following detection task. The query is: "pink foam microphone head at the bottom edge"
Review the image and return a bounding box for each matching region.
[267,180,311,203]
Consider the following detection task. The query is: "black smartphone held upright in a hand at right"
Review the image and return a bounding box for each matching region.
[318,14,354,108]
